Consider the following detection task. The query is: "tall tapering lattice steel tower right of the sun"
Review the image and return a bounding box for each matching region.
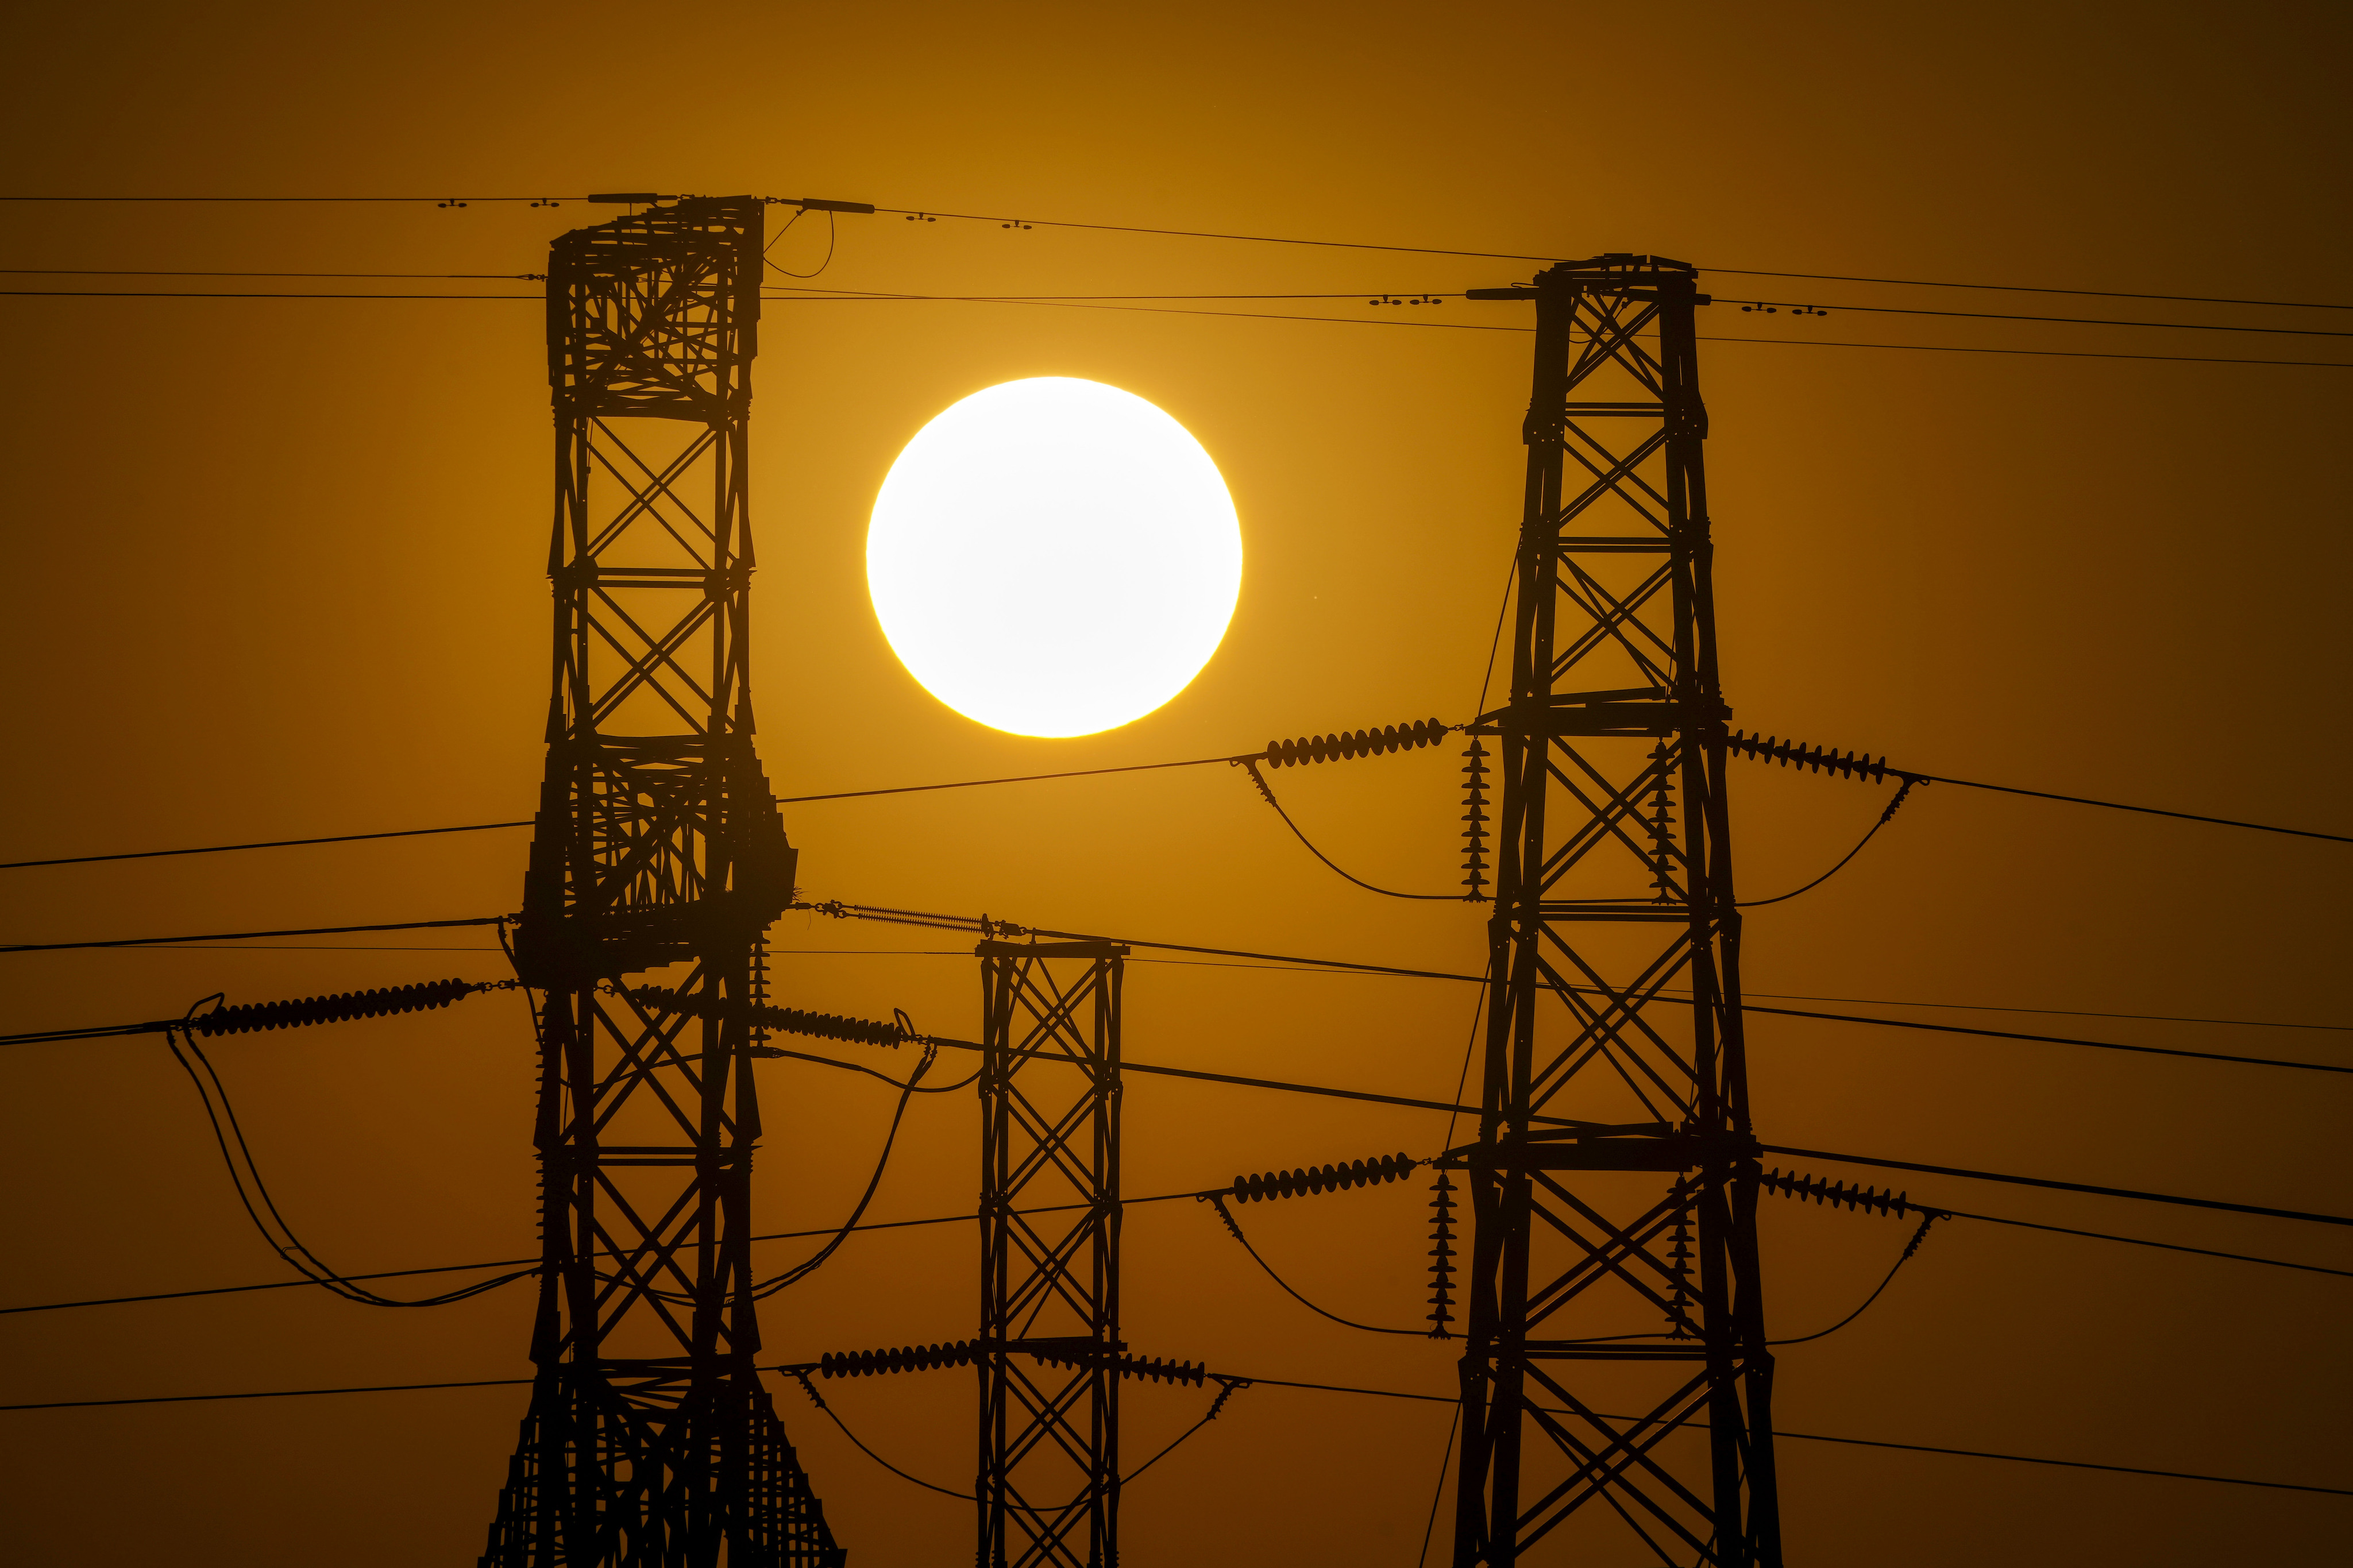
[1449,256,1781,1568]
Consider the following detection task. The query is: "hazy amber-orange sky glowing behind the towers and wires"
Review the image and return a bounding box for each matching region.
[0,0,2353,1568]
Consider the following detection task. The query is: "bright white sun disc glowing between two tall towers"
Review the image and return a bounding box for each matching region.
[866,376,1243,736]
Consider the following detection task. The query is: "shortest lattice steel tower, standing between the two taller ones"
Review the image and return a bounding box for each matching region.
[974,940,1127,1568]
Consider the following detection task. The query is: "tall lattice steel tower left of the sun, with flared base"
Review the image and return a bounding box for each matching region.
[483,198,842,1568]
